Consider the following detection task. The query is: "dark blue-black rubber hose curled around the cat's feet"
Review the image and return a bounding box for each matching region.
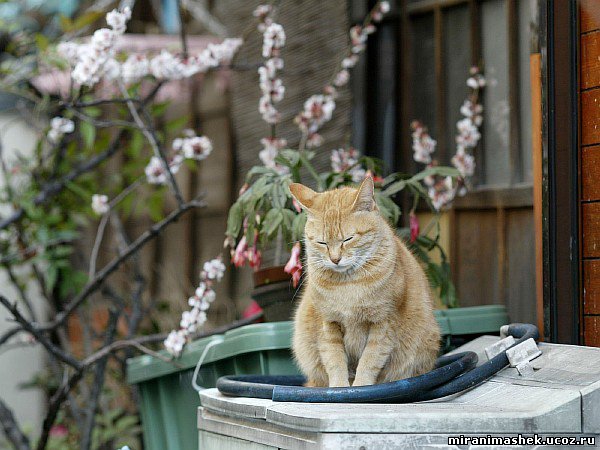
[217,323,539,403]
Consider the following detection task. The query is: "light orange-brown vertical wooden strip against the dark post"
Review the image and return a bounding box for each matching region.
[529,53,544,337]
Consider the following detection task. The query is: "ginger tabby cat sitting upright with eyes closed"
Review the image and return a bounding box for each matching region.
[290,177,440,387]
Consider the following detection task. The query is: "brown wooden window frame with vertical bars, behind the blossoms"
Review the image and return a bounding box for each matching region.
[397,0,533,209]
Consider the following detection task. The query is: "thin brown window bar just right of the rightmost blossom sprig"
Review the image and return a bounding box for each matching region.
[506,0,523,185]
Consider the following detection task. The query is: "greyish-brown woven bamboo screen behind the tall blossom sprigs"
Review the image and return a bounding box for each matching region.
[214,0,351,184]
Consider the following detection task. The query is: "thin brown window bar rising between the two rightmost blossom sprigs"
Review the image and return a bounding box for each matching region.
[433,6,448,164]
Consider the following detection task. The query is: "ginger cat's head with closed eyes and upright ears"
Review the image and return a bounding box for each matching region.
[290,177,381,273]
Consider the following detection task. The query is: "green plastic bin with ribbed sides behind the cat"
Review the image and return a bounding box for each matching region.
[127,305,509,450]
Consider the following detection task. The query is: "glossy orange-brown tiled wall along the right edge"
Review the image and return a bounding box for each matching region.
[579,0,600,347]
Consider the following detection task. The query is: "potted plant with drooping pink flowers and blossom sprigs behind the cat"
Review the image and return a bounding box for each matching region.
[226,2,465,321]
